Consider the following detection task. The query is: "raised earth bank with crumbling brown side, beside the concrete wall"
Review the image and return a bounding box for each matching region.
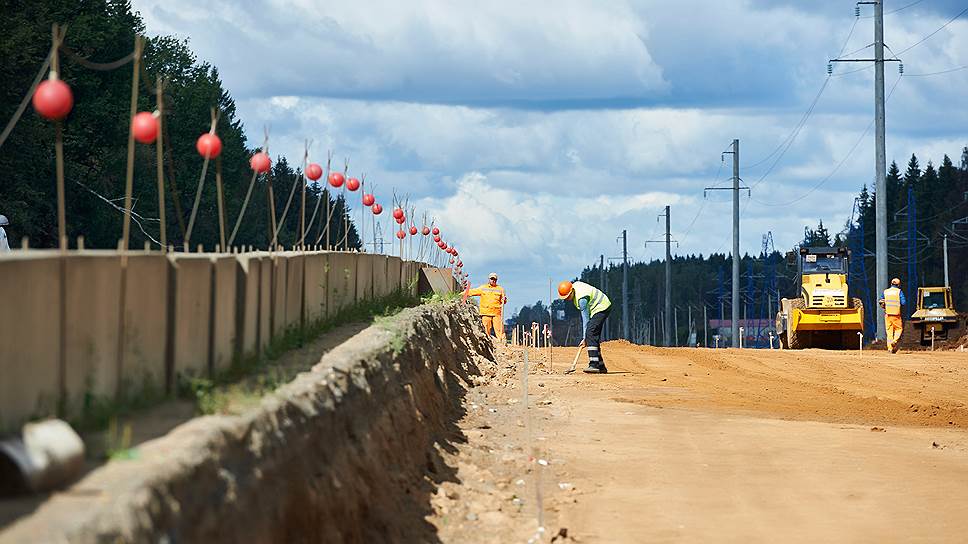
[0,304,494,542]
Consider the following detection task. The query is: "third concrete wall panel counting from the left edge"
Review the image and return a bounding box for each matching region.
[121,253,174,398]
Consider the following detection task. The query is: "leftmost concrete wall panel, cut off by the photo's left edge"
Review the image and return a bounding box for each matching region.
[0,251,61,429]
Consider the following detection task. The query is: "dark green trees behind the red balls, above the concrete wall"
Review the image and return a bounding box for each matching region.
[0,0,360,250]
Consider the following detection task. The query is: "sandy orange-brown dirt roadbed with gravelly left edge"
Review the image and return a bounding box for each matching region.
[435,342,968,542]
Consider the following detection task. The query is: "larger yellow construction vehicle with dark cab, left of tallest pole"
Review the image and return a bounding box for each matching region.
[776,247,864,349]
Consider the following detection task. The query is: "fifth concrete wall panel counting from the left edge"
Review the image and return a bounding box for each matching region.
[211,255,239,372]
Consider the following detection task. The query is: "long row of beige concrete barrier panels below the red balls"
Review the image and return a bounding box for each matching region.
[0,250,450,431]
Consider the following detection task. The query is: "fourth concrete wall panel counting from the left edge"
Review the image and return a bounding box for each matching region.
[170,254,213,378]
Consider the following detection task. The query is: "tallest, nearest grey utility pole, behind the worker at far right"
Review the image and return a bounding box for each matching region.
[827,0,903,340]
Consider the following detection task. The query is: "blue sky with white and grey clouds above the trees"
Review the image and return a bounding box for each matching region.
[133,0,968,317]
